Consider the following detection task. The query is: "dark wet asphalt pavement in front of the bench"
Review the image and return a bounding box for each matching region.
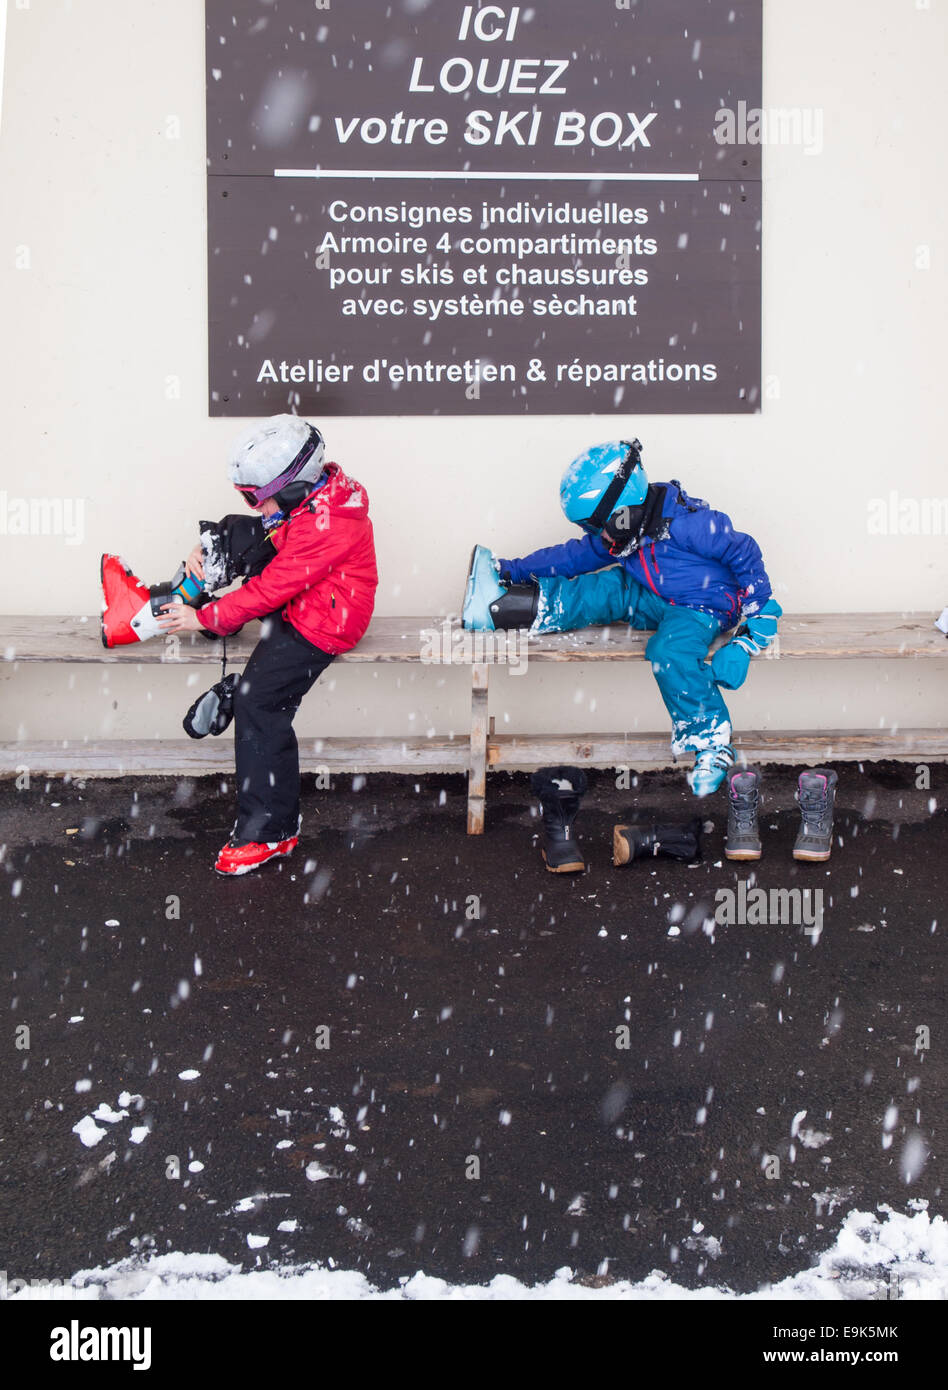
[0,763,948,1291]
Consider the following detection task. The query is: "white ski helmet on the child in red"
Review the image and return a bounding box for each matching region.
[227,416,325,509]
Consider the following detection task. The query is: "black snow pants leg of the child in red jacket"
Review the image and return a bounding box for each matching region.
[234,613,332,845]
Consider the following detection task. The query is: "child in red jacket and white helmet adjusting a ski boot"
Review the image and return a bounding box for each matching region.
[103,416,378,874]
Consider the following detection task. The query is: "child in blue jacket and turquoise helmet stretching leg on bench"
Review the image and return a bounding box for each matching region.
[463,439,783,796]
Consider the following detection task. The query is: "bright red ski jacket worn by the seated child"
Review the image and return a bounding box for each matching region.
[197,463,378,655]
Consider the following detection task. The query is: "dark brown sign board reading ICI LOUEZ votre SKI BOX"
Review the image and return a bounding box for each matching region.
[206,0,760,416]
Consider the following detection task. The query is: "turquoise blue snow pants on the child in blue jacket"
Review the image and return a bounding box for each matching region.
[531,566,731,756]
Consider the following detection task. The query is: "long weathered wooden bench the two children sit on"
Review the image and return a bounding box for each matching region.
[0,613,948,835]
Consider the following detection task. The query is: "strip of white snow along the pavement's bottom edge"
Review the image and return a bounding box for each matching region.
[10,1202,948,1300]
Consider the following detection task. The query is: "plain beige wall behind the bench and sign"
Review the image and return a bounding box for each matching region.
[0,0,948,738]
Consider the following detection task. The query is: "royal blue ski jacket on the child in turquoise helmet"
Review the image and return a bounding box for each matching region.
[499,480,773,628]
